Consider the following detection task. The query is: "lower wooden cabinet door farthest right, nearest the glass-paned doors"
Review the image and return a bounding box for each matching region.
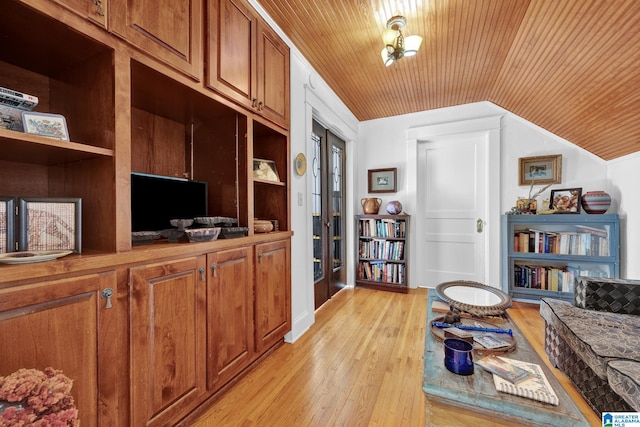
[255,240,291,352]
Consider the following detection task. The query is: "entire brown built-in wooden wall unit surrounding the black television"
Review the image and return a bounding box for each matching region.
[0,0,292,426]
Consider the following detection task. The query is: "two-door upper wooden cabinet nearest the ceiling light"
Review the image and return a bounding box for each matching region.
[207,0,289,129]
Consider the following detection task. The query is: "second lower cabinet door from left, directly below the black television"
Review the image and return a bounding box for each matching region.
[129,257,206,426]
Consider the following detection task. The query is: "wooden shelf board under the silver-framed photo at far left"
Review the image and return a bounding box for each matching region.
[0,129,113,166]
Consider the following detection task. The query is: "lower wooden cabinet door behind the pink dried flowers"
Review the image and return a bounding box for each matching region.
[0,272,120,426]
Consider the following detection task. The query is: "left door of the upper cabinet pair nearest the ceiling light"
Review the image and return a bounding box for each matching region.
[207,0,258,108]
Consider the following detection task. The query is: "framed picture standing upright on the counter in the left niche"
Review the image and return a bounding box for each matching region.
[18,197,82,253]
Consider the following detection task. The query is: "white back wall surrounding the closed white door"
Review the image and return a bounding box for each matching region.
[353,102,628,285]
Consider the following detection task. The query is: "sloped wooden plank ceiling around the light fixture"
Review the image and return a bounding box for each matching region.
[258,0,640,160]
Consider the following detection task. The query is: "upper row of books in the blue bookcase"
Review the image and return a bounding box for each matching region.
[513,226,609,256]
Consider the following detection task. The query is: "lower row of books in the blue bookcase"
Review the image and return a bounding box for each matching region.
[513,264,608,292]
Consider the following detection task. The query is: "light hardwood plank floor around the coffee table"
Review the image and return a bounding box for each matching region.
[193,288,601,427]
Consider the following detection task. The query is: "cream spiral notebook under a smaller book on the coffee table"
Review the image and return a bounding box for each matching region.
[493,357,560,406]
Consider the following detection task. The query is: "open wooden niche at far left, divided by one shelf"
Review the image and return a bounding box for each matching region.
[0,2,116,252]
